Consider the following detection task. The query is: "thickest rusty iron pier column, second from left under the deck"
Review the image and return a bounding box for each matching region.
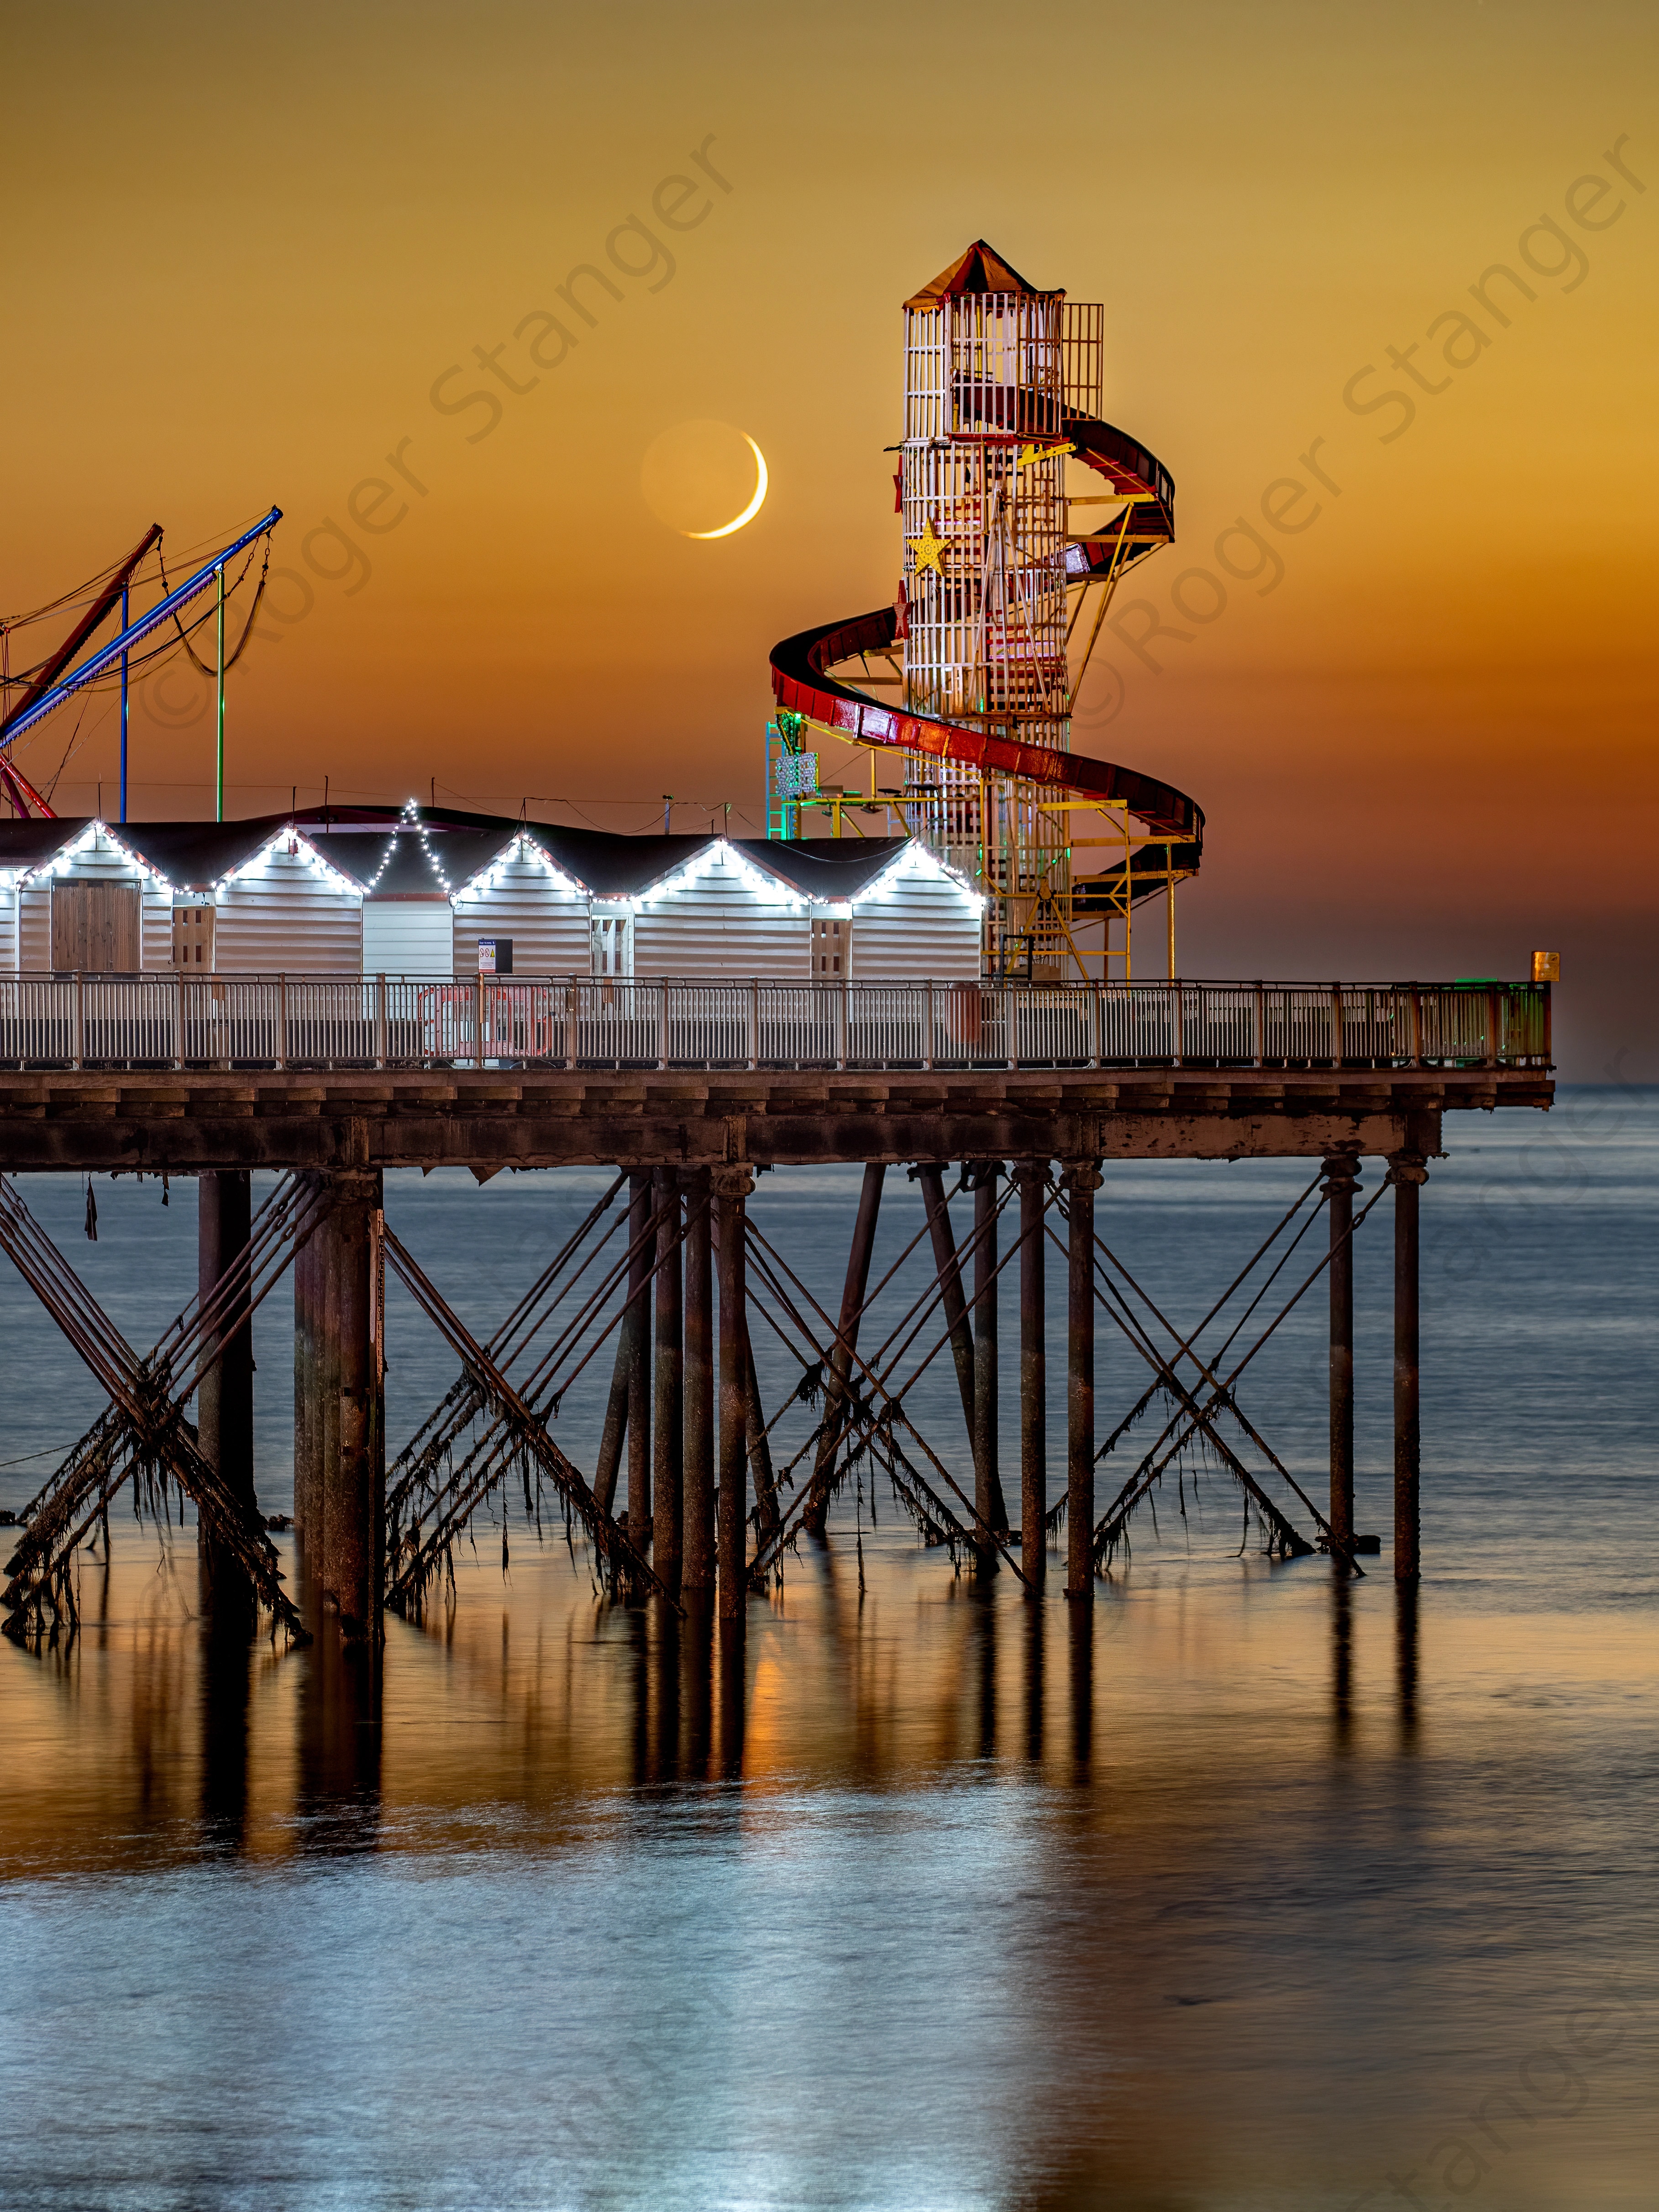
[319,1172,385,1641]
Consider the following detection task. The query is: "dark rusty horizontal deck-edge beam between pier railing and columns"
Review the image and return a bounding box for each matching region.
[0,1068,1555,1177]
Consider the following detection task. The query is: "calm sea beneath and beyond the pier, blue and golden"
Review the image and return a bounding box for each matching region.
[0,1088,1659,2212]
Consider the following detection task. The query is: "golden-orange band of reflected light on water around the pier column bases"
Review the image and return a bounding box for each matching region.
[0,1529,1637,1871]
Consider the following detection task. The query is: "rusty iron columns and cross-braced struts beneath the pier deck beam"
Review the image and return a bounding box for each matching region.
[0,1088,1469,1639]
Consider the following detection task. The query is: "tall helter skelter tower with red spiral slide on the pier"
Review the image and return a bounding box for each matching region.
[767,239,1203,977]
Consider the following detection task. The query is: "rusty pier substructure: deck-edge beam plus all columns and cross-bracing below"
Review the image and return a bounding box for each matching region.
[0,1066,1553,1641]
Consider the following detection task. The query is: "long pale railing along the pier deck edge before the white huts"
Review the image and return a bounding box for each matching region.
[0,973,1551,1071]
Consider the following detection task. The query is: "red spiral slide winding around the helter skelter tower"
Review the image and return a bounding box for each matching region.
[772,409,1203,898]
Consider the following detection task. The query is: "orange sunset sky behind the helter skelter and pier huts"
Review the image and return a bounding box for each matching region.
[0,0,1659,1079]
